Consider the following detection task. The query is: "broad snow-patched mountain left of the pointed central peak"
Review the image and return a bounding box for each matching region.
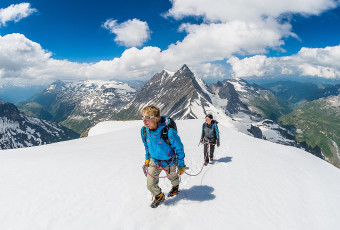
[20,80,136,134]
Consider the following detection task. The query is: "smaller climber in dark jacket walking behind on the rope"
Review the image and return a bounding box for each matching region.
[200,114,220,165]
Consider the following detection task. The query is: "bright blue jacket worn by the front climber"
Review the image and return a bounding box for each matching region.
[141,116,185,168]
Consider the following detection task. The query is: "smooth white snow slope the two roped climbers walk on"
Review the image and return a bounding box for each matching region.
[0,120,340,230]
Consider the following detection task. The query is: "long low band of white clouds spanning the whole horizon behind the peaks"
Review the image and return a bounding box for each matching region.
[0,34,340,87]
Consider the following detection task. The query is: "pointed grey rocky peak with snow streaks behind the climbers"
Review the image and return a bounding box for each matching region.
[124,65,223,119]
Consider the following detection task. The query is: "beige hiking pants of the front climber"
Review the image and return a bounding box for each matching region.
[146,159,179,196]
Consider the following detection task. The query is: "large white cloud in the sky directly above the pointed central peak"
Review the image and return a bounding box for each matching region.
[164,19,294,64]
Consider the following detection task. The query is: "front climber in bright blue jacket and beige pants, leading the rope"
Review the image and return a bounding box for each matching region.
[141,105,185,208]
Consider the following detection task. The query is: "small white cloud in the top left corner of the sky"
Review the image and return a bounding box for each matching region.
[0,3,37,26]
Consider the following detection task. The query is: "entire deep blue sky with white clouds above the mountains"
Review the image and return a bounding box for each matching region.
[0,0,340,84]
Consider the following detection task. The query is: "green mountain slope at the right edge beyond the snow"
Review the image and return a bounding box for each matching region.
[280,94,340,168]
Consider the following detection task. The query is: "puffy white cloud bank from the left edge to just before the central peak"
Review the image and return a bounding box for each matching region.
[0,34,164,84]
